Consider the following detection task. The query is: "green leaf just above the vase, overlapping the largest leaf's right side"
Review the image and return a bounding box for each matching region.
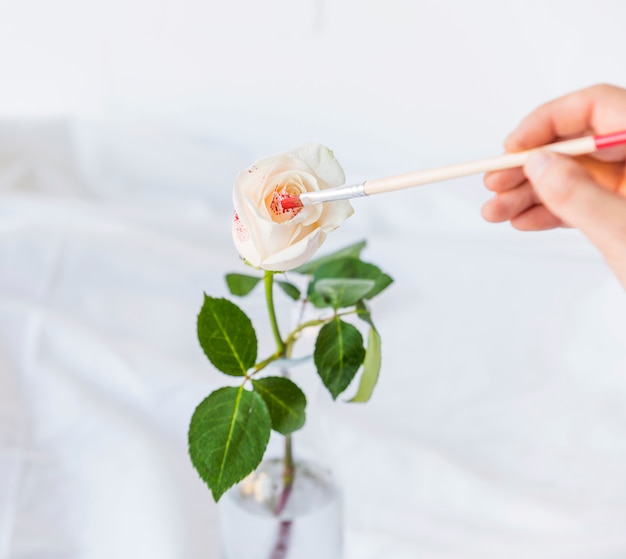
[252,377,306,435]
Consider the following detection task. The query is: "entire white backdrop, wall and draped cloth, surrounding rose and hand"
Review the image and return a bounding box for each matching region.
[0,0,626,559]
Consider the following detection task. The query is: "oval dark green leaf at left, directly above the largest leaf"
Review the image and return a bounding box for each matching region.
[198,295,257,376]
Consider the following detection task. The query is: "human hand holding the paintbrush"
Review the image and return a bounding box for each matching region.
[482,85,626,287]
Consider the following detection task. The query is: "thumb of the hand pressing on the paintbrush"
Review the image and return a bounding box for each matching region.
[524,150,626,260]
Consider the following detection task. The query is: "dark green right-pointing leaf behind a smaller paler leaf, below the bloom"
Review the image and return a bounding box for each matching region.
[309,258,393,308]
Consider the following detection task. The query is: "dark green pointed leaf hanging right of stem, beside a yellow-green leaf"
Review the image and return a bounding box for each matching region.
[313,317,365,399]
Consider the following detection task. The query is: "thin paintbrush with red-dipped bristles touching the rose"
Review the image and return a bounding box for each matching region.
[275,130,626,210]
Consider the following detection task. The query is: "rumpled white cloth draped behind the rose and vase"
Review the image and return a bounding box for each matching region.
[0,120,626,559]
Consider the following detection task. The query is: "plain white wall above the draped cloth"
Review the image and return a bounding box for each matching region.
[0,0,626,164]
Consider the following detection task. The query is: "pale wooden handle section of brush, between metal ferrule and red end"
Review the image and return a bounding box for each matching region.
[363,136,597,195]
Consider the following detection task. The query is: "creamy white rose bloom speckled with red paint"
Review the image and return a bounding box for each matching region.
[233,144,354,272]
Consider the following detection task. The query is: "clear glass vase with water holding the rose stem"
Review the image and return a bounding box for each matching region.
[214,356,343,559]
